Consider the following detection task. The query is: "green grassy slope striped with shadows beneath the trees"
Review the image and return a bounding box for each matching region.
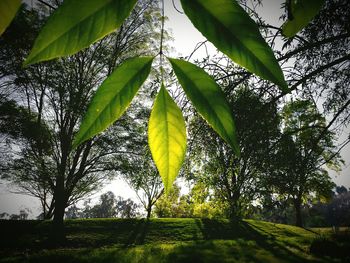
[0,219,346,263]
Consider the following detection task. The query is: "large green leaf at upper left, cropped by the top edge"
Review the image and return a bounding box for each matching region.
[24,0,136,65]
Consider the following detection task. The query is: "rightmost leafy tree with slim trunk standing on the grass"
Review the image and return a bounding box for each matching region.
[268,100,341,226]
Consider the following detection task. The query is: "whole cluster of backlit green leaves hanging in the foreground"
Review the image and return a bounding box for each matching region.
[4,0,322,192]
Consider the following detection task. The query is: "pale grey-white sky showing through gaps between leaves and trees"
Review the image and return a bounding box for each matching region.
[0,0,350,218]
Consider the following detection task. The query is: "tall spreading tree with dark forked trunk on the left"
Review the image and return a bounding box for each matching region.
[0,0,160,243]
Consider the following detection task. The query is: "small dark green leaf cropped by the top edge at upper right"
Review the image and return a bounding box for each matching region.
[282,0,324,37]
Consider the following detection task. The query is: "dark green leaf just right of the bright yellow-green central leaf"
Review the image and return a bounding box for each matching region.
[169,58,240,156]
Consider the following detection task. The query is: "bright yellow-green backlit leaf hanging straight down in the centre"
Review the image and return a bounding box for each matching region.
[148,85,186,193]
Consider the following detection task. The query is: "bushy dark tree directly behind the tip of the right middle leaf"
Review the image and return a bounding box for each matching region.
[190,88,279,218]
